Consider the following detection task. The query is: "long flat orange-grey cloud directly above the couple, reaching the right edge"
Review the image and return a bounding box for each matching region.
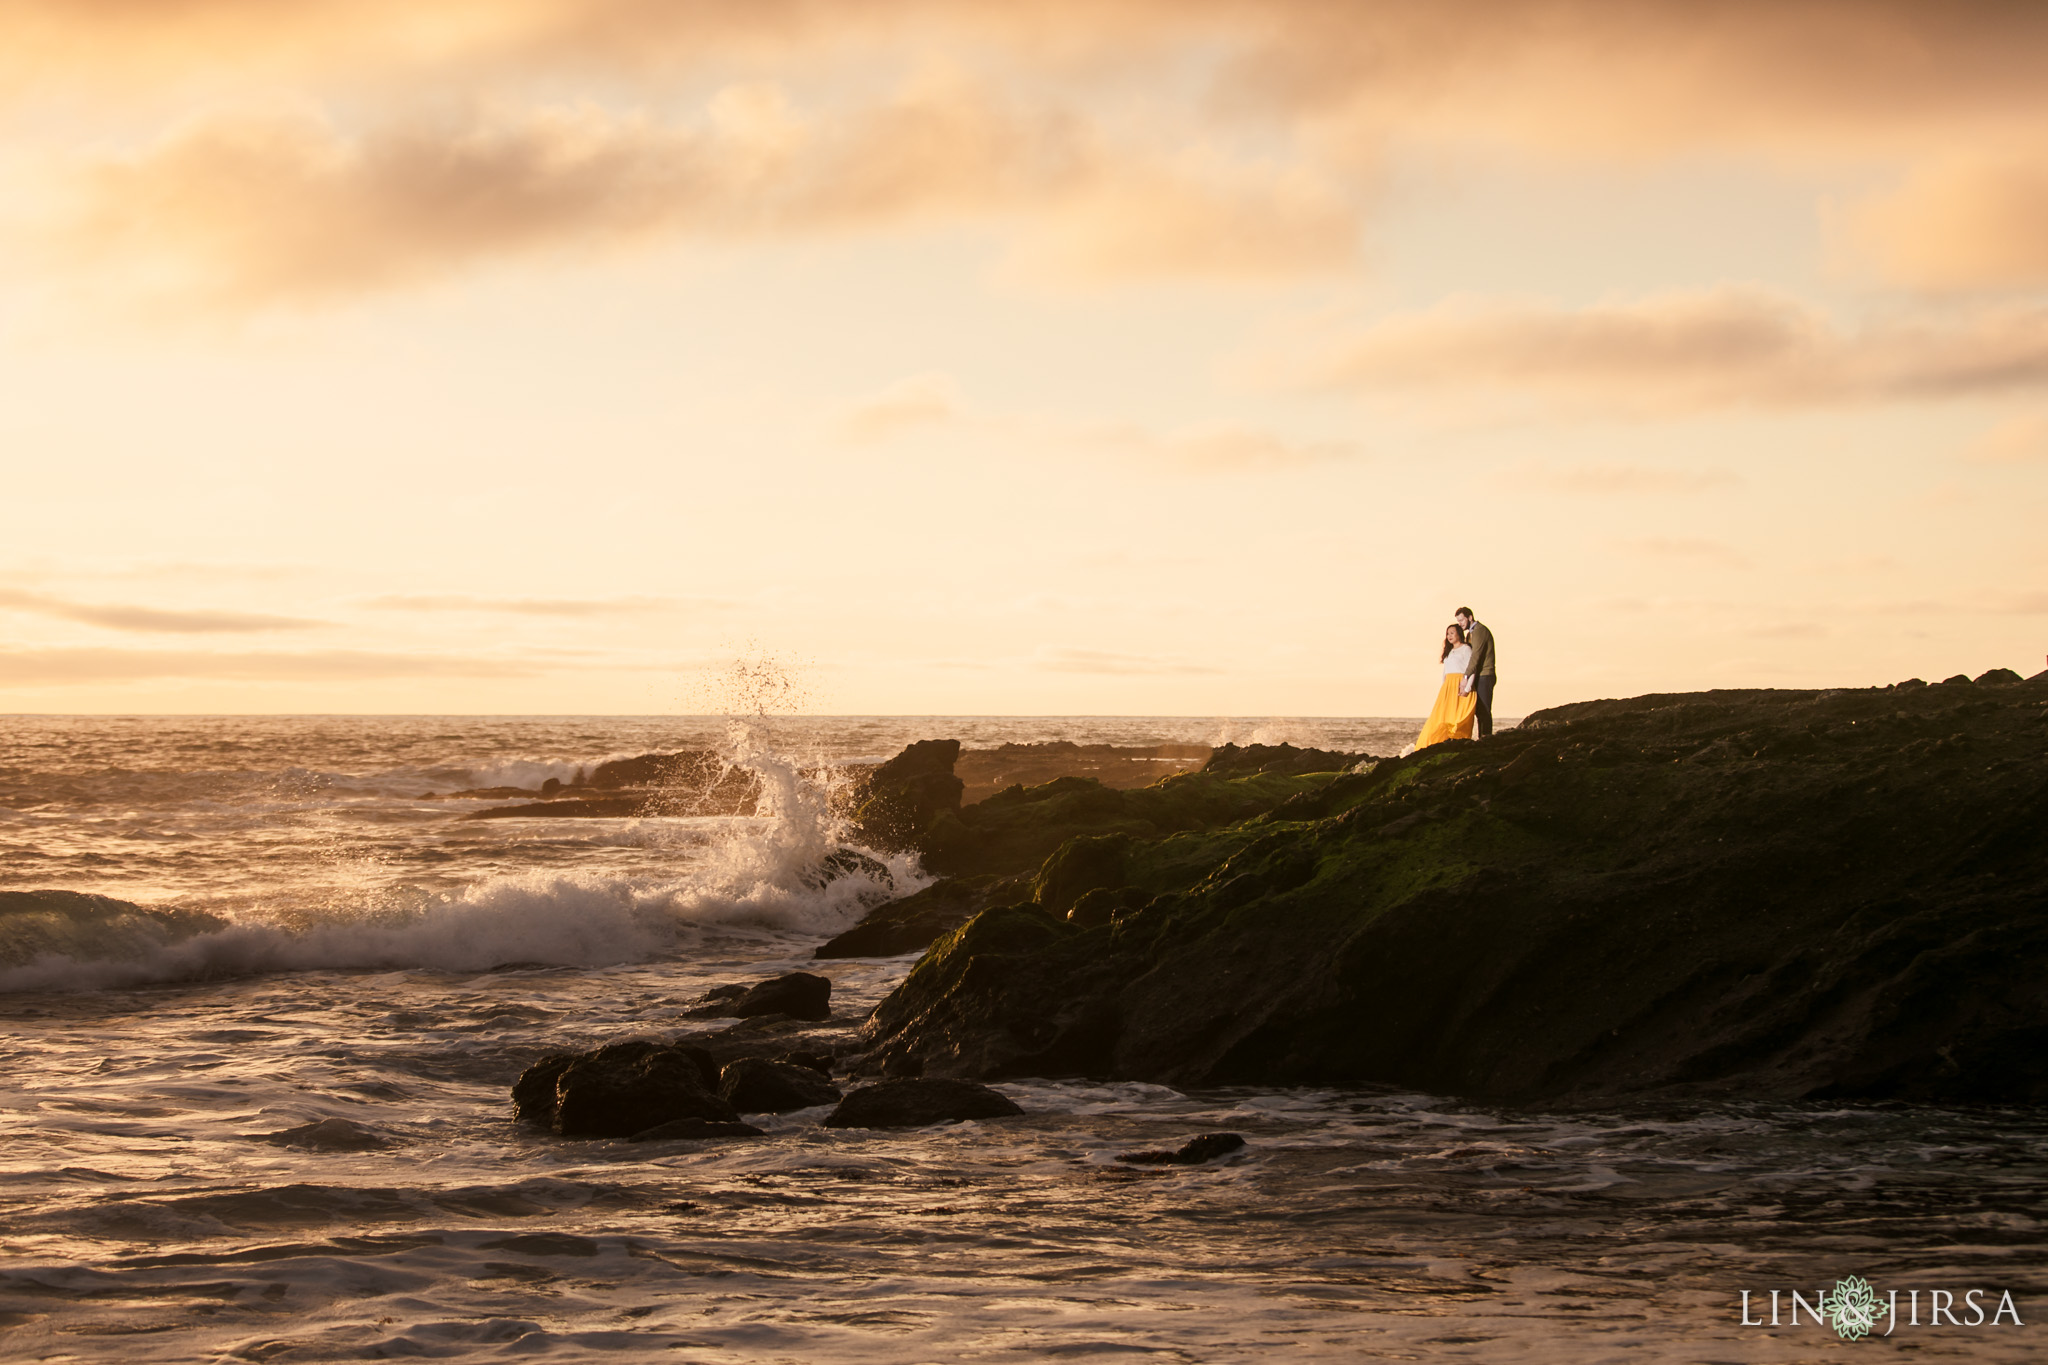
[1294,289,2048,413]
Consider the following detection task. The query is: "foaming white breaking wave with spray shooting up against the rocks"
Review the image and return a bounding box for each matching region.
[0,695,926,990]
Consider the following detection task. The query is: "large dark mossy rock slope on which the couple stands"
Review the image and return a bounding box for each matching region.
[856,675,2048,1101]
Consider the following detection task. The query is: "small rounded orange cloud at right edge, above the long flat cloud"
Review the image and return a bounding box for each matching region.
[1849,156,2048,289]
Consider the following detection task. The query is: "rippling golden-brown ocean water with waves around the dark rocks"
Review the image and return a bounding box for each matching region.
[0,716,2048,1363]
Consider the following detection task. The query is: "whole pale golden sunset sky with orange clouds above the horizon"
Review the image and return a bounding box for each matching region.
[0,0,2048,714]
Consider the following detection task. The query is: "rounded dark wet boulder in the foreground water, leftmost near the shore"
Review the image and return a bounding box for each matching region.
[512,1038,739,1138]
